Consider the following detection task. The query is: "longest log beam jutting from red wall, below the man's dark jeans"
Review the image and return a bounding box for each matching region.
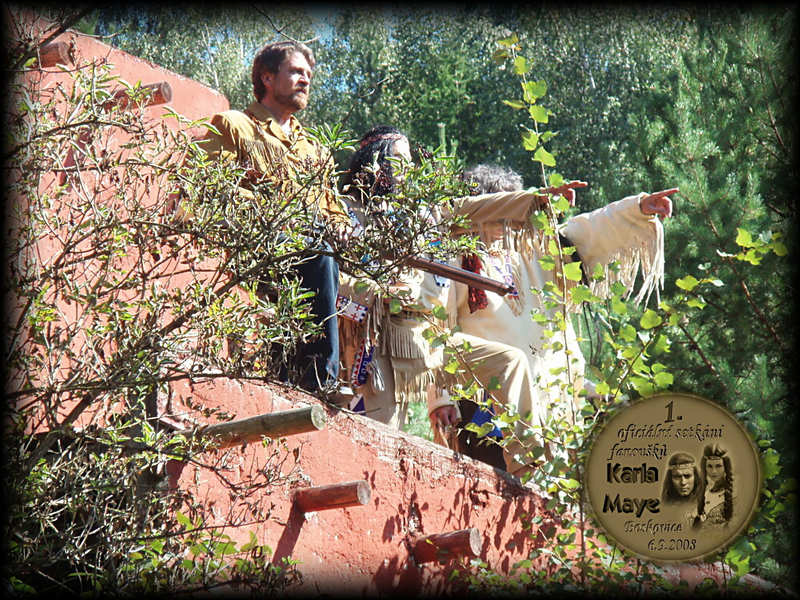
[184,404,326,448]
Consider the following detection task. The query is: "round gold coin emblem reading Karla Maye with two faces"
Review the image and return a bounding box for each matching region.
[585,393,761,562]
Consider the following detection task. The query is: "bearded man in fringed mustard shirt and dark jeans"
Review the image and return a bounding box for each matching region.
[199,42,349,390]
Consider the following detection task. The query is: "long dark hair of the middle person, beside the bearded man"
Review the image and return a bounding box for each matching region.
[342,125,406,203]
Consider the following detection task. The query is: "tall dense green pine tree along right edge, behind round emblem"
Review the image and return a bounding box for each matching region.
[616,7,797,581]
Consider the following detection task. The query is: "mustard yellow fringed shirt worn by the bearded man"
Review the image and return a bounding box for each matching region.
[202,102,349,223]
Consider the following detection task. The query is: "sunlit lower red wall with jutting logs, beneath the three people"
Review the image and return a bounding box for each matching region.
[164,380,555,595]
